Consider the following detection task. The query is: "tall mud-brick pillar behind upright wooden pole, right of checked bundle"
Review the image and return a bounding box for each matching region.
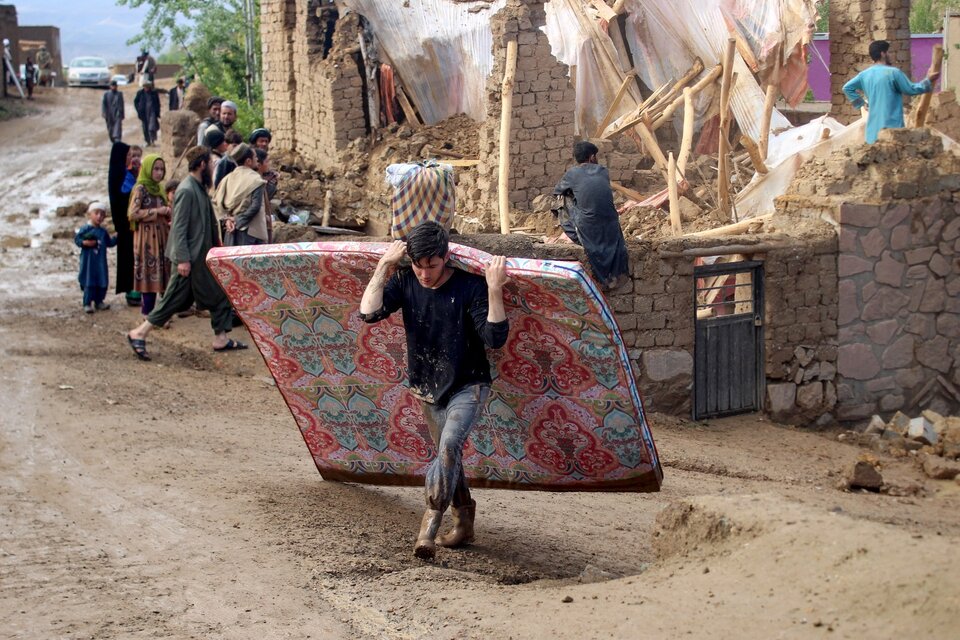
[464,0,576,228]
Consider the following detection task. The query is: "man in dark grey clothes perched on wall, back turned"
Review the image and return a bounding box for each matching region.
[553,141,630,289]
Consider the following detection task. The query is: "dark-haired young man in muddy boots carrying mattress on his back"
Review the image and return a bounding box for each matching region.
[360,222,510,559]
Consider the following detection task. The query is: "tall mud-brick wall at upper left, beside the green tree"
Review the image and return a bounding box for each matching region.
[261,0,368,168]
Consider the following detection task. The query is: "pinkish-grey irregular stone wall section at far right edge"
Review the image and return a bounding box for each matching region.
[837,196,960,420]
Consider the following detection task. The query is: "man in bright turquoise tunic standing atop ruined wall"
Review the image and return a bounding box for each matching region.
[843,40,940,144]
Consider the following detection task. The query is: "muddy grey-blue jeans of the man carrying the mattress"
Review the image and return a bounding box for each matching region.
[420,384,490,511]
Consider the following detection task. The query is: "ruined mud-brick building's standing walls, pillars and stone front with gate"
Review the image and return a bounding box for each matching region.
[261,5,960,425]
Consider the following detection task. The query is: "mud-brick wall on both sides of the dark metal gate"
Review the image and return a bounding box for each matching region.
[456,229,837,425]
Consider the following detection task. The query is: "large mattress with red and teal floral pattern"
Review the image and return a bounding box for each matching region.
[207,242,663,491]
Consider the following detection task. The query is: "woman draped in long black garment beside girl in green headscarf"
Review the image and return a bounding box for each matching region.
[107,142,143,307]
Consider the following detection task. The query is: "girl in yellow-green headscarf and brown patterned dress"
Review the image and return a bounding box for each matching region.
[127,154,173,316]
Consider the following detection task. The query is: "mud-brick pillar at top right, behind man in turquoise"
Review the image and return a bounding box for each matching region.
[830,0,910,122]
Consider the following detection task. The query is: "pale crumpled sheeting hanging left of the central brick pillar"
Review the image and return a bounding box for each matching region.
[339,0,505,124]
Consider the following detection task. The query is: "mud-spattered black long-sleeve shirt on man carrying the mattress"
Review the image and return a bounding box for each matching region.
[360,267,510,406]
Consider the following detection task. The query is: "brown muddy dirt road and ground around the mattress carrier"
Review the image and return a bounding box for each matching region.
[0,89,960,640]
